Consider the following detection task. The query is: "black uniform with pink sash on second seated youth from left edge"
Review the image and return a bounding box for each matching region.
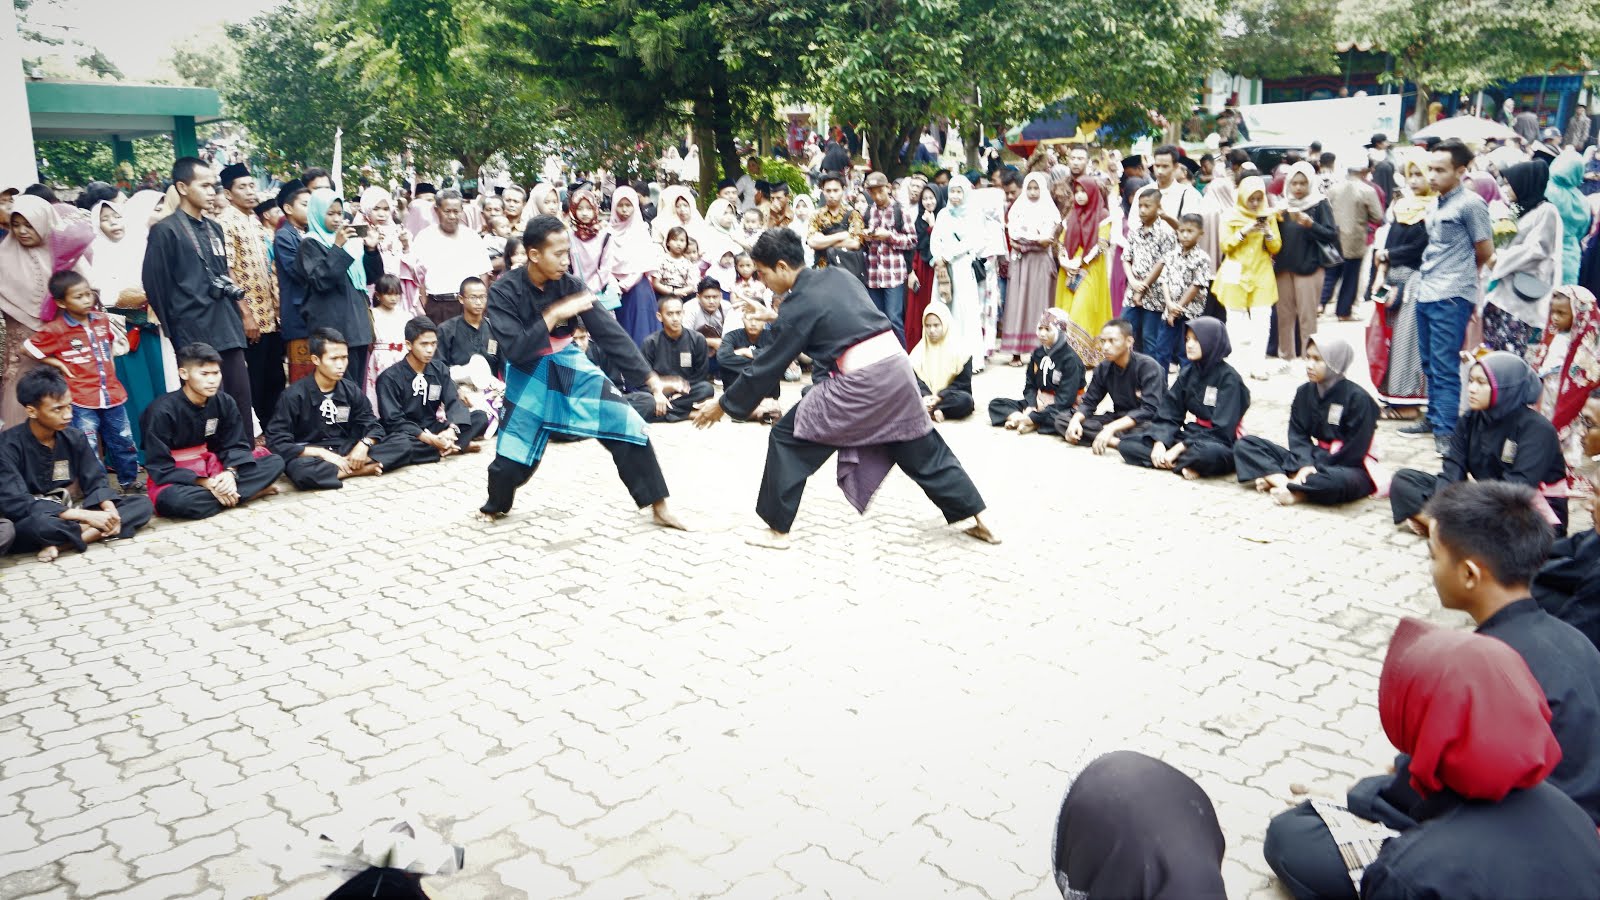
[139,388,283,519]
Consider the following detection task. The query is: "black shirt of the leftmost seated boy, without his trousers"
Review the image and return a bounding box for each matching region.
[0,421,115,520]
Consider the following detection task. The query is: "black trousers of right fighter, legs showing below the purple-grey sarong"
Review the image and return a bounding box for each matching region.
[755,410,984,533]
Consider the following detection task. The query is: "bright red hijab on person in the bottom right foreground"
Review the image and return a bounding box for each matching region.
[1378,618,1562,802]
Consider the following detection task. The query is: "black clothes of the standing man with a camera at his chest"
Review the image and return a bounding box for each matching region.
[142,210,254,422]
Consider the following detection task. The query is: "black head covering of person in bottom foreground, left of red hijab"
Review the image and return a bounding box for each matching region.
[1054,749,1227,900]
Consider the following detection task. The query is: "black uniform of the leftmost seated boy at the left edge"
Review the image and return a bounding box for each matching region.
[0,421,155,552]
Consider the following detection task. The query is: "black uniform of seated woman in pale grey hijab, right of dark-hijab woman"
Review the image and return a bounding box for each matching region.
[1234,378,1378,506]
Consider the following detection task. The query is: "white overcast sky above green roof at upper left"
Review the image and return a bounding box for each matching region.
[21,0,282,82]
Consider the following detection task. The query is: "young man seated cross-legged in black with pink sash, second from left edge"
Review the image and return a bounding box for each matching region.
[139,341,283,519]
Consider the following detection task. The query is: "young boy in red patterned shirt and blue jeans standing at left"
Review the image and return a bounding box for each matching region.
[22,271,139,493]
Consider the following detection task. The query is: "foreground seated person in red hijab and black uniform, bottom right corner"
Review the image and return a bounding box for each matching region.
[1262,611,1600,900]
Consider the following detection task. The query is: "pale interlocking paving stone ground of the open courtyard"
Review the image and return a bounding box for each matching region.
[0,315,1510,900]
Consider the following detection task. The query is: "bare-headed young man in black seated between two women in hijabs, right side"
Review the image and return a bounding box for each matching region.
[1056,319,1166,455]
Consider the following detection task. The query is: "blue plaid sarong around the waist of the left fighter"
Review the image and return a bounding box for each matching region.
[494,344,648,466]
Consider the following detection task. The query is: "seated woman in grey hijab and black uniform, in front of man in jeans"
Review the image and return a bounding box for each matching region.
[1389,351,1566,535]
